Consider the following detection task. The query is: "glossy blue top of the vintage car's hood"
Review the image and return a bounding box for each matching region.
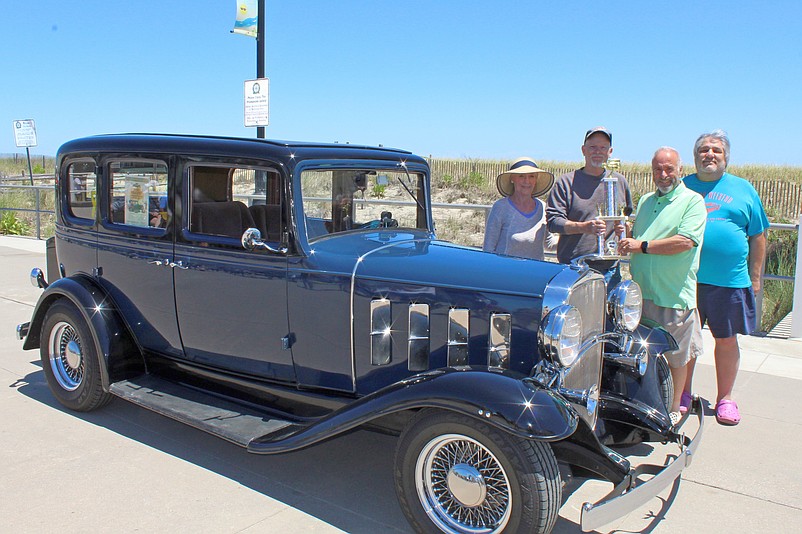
[311,230,569,296]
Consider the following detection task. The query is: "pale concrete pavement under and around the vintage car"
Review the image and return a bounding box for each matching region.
[0,237,802,534]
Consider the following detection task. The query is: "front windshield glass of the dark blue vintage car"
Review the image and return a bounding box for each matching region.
[301,169,428,241]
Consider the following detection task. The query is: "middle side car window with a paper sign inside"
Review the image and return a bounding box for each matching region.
[108,160,168,228]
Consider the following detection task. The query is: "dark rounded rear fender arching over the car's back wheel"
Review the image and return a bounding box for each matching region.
[22,276,144,391]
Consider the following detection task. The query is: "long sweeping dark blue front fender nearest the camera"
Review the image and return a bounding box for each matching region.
[248,366,579,454]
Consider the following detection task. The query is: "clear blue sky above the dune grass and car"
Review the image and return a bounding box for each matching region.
[0,0,802,165]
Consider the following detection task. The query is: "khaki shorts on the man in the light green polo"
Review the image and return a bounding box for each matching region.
[643,299,704,369]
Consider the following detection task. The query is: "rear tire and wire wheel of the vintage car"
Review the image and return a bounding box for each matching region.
[39,300,112,412]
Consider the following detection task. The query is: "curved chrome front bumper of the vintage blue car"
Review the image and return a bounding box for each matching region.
[580,396,704,532]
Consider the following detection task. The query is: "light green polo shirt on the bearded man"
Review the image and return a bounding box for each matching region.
[630,182,707,310]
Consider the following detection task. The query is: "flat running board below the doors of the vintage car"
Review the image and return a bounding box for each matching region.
[109,375,302,447]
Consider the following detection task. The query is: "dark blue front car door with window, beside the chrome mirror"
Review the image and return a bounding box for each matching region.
[173,162,295,382]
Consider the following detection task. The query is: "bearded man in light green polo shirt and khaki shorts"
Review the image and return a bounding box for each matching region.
[619,147,707,423]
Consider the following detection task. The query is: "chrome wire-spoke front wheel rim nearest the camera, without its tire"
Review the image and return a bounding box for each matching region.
[415,434,512,534]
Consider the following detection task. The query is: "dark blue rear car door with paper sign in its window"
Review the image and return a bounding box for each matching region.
[97,157,183,357]
